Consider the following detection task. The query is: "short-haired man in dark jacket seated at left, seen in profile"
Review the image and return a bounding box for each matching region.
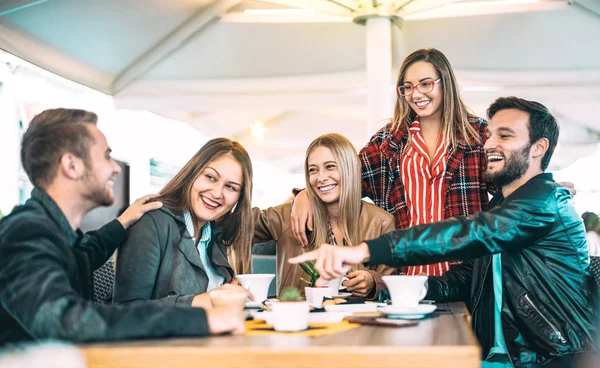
[0,109,244,344]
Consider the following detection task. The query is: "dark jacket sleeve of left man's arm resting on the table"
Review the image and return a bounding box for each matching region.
[0,221,216,342]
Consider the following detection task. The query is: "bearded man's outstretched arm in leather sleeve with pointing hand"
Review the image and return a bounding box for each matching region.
[289,197,556,280]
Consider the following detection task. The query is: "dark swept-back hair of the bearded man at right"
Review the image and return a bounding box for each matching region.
[487,96,560,170]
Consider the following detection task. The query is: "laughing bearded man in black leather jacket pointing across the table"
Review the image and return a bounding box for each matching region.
[290,97,594,367]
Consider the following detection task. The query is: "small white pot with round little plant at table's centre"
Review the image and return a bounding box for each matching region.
[267,288,310,331]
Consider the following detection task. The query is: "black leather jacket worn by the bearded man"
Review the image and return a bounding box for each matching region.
[367,174,594,367]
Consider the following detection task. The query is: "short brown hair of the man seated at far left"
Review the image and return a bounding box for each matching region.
[21,109,98,188]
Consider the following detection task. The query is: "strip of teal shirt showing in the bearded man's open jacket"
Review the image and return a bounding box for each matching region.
[482,253,512,368]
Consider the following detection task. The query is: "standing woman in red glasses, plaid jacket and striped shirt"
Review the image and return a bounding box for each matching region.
[292,49,488,276]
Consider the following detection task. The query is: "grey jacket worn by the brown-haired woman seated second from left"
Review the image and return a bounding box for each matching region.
[113,207,235,306]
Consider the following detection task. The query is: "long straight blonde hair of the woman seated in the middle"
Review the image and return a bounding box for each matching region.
[304,133,362,249]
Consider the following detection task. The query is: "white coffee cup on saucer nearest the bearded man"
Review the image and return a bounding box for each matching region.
[382,275,427,308]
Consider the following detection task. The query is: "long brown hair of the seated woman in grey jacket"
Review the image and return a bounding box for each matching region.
[156,138,254,274]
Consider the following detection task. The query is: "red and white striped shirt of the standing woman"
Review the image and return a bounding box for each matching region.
[400,118,450,276]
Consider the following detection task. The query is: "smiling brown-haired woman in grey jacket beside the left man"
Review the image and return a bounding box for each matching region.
[114,138,253,307]
